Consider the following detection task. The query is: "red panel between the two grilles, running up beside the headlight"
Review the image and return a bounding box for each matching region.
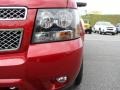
[0,9,37,55]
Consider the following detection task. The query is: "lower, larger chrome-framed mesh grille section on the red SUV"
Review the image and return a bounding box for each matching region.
[0,29,23,51]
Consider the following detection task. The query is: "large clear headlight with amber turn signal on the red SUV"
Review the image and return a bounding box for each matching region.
[32,9,80,43]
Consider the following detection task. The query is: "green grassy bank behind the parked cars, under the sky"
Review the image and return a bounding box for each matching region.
[82,14,120,26]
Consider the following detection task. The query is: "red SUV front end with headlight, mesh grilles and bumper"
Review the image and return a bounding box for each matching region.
[0,0,84,90]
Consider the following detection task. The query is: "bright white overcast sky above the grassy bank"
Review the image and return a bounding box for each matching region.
[77,0,120,14]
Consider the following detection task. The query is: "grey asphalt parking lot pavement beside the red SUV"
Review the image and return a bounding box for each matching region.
[69,34,120,90]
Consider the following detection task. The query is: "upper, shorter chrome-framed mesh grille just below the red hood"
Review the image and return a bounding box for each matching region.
[0,7,27,20]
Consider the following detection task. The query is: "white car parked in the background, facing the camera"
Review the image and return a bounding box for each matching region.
[92,21,117,35]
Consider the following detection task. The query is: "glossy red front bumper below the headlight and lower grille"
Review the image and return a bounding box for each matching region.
[0,39,83,90]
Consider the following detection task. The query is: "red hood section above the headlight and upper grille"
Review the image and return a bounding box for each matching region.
[0,0,68,8]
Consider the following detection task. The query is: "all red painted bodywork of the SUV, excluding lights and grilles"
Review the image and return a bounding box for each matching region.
[0,0,84,90]
